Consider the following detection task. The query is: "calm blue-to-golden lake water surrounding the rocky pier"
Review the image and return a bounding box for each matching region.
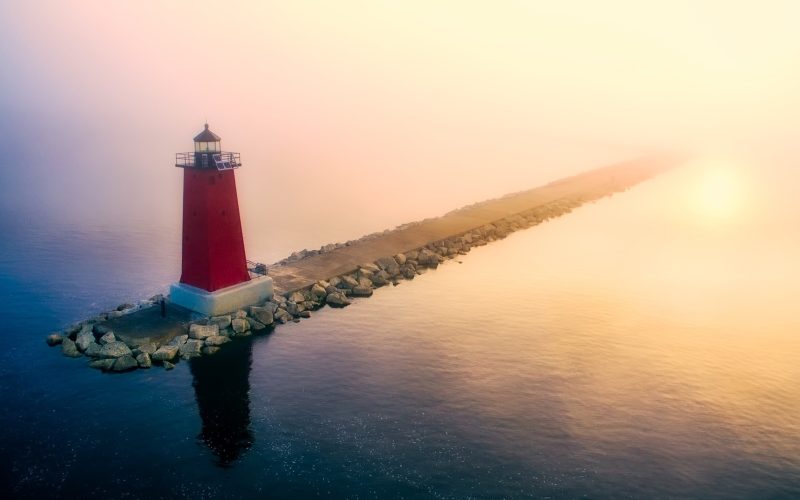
[0,164,800,498]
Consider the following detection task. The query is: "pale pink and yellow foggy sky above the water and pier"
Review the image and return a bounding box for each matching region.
[0,0,800,260]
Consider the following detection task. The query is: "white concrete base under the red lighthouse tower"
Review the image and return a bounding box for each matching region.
[169,276,272,316]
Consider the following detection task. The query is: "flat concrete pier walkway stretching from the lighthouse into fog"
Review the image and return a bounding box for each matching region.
[269,157,679,293]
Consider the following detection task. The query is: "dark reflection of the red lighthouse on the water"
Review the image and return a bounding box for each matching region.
[189,339,253,468]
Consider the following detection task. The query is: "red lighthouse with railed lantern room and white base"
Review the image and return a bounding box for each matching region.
[170,124,272,315]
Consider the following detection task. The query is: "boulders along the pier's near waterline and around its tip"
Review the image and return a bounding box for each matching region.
[47,193,588,372]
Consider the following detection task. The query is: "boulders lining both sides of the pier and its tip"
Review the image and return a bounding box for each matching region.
[46,154,680,372]
